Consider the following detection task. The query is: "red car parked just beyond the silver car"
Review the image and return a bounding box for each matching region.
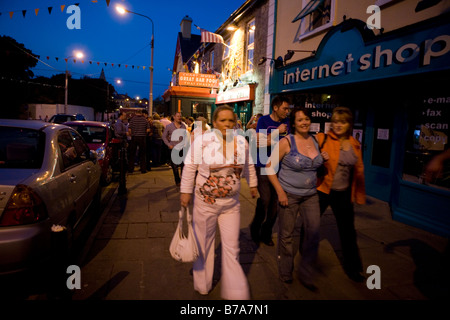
[63,121,116,185]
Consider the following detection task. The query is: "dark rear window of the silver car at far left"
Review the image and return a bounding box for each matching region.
[0,127,45,169]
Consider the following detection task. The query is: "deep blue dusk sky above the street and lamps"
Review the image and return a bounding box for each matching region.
[0,0,245,99]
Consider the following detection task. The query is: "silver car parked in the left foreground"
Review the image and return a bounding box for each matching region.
[0,119,101,274]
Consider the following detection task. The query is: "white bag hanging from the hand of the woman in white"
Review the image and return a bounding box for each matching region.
[169,207,199,262]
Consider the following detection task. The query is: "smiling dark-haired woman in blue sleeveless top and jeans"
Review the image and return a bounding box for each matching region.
[267,107,326,291]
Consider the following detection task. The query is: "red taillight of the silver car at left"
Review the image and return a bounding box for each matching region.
[0,185,48,227]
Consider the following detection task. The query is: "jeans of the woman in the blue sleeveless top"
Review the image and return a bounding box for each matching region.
[278,193,320,281]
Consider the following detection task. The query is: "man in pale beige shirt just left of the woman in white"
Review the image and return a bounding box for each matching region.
[163,112,188,186]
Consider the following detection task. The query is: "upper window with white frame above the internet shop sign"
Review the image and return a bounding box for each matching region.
[292,0,335,40]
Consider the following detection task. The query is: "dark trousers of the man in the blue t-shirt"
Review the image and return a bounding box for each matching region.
[250,166,278,241]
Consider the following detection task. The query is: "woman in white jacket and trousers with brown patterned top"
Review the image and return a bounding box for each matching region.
[180,105,257,300]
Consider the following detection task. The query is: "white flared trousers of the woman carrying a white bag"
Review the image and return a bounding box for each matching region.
[193,197,250,300]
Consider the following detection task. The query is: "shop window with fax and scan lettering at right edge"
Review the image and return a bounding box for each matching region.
[403,96,450,189]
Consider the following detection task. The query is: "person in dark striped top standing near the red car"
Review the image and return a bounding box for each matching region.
[128,111,150,173]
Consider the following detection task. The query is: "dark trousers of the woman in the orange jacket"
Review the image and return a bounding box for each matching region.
[318,188,363,273]
